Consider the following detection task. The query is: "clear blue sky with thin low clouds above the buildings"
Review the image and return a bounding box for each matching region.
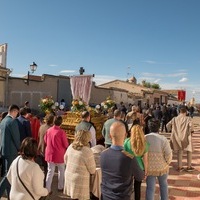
[0,0,200,102]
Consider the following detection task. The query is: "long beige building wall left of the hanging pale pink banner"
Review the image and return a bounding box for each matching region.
[8,75,71,110]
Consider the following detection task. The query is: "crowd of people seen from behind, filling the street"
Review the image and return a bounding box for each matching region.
[0,102,194,200]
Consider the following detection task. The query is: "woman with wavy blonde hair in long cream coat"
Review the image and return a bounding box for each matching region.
[64,130,96,200]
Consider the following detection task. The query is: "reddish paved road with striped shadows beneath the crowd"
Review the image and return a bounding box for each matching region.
[2,116,200,200]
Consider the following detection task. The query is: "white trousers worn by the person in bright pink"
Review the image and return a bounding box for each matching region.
[46,162,65,192]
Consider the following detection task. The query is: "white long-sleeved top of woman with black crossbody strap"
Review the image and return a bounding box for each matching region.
[7,156,48,200]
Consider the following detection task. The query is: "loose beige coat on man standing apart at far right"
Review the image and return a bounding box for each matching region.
[167,114,194,152]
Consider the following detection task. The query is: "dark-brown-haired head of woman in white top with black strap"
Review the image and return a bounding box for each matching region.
[20,137,37,159]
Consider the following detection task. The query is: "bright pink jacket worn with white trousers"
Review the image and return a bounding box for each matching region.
[44,125,69,163]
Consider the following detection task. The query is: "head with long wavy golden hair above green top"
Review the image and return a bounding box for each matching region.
[130,124,145,156]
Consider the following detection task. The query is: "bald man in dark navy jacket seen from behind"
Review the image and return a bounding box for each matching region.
[100,121,144,200]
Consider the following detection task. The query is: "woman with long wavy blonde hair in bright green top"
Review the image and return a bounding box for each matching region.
[124,124,149,200]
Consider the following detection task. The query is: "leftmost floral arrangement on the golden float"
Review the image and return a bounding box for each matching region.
[39,96,55,113]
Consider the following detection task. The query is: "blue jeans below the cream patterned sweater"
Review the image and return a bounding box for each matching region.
[146,174,168,200]
